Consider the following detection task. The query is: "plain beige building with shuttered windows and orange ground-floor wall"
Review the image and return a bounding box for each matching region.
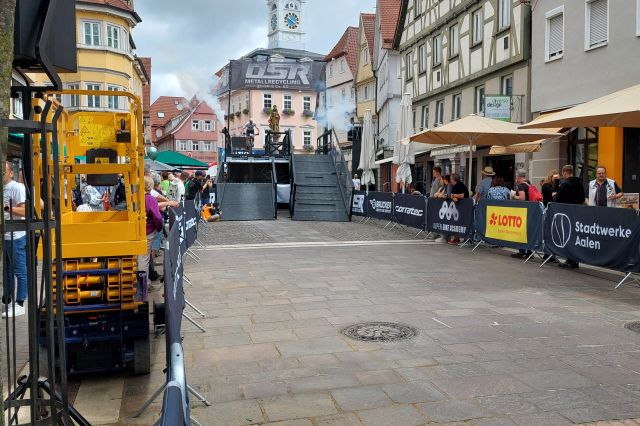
[530,0,640,193]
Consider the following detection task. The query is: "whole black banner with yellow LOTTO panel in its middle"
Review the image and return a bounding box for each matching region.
[474,200,543,250]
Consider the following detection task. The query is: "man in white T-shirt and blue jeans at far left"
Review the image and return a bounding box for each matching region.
[2,162,27,317]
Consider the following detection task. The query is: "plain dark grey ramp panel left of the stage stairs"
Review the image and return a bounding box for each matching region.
[217,183,275,220]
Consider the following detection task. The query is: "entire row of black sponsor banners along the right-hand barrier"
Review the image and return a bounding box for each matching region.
[352,191,640,280]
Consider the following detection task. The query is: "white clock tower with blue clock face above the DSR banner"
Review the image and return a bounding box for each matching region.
[267,0,306,50]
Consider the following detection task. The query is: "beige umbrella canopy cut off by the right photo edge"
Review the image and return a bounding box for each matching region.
[520,84,640,129]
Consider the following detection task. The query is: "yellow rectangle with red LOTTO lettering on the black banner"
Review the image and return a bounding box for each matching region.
[485,206,528,244]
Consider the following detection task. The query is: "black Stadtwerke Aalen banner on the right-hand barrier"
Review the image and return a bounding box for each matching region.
[544,203,640,272]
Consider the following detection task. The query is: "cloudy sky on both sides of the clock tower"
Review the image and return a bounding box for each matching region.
[133,0,375,100]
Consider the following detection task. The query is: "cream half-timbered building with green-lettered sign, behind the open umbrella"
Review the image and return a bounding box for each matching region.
[395,0,542,189]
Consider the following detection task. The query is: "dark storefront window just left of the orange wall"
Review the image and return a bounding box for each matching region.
[568,127,598,188]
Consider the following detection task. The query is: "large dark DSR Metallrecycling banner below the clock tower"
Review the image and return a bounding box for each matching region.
[226,59,325,91]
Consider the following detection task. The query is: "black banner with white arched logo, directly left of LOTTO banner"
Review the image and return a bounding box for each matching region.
[426,198,474,237]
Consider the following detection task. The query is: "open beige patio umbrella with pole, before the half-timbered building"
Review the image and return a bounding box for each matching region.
[409,114,562,185]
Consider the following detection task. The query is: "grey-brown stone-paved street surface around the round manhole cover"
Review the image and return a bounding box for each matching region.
[28,219,640,426]
